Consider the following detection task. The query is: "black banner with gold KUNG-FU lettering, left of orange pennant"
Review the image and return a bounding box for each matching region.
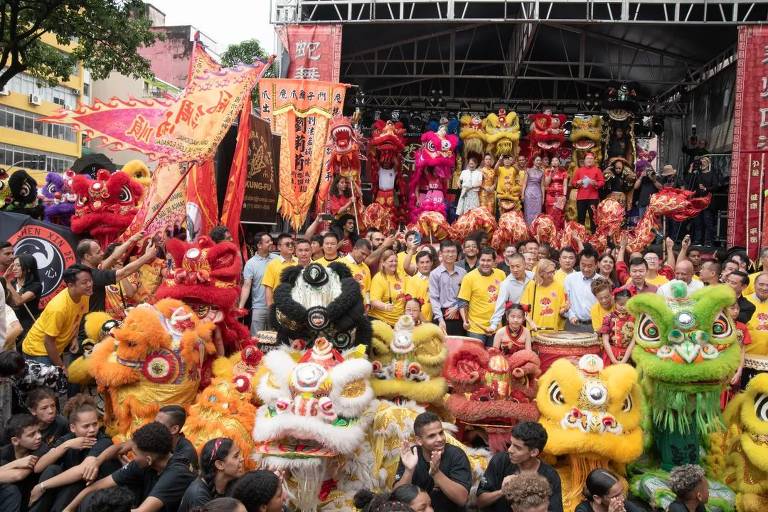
[240,116,280,224]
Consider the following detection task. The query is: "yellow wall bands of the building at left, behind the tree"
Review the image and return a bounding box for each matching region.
[0,34,84,184]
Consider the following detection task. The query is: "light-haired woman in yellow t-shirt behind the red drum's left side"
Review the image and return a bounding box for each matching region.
[520,259,569,331]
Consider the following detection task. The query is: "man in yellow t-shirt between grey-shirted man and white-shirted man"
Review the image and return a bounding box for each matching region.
[458,247,506,347]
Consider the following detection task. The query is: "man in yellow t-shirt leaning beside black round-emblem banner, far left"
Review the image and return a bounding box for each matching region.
[21,264,93,372]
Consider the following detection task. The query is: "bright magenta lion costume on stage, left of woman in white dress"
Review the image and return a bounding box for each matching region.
[408,126,459,223]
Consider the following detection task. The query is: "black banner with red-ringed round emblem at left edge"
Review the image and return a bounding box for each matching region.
[0,212,78,308]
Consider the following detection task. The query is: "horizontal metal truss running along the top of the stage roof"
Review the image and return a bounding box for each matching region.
[271,0,768,25]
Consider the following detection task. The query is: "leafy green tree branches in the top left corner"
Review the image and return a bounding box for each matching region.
[0,0,155,87]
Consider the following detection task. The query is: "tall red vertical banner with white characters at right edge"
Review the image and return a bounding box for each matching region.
[728,25,768,258]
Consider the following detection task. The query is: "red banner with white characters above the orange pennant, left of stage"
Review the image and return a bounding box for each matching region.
[278,25,341,82]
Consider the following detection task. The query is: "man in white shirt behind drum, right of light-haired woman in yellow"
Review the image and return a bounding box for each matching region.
[564,245,599,332]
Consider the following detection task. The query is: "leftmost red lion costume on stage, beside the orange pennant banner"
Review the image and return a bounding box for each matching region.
[321,117,365,229]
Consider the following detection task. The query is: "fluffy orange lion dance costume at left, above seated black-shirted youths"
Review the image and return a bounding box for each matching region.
[90,299,215,437]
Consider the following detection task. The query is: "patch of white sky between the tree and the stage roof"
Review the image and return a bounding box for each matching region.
[145,0,275,54]
